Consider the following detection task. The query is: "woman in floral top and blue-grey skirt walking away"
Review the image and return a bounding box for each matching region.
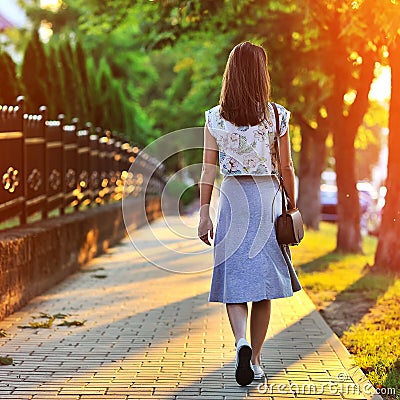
[198,42,301,386]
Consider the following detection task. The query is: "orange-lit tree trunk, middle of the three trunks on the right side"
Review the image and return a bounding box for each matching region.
[327,15,375,253]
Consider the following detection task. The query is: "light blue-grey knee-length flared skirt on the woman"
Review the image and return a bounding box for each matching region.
[208,175,301,303]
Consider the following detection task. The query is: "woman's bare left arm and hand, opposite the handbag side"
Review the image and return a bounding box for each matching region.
[198,124,218,246]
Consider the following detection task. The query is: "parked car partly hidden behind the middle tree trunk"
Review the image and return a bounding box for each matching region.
[320,182,381,235]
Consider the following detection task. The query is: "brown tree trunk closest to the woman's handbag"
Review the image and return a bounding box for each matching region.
[298,127,327,229]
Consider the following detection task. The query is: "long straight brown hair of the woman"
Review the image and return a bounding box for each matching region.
[219,41,270,126]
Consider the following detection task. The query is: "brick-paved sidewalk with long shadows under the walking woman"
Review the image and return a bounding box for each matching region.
[0,211,380,400]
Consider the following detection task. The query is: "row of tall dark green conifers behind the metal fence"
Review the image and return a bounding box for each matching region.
[5,31,149,146]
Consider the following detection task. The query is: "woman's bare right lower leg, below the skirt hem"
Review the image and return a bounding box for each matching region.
[250,300,271,365]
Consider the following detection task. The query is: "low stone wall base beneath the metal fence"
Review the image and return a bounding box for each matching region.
[0,197,161,319]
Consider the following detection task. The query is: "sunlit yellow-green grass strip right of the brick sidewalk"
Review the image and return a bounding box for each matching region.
[292,223,400,400]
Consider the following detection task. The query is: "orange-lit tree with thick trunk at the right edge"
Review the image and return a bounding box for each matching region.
[340,0,400,271]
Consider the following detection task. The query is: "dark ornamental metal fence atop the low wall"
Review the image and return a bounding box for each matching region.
[0,97,165,224]
